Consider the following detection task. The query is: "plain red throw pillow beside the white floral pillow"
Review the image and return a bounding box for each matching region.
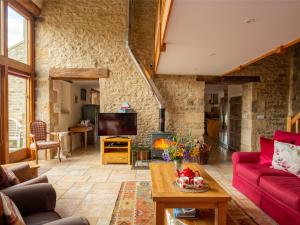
[258,137,274,167]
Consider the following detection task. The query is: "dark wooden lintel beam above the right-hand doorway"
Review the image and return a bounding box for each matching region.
[196,76,260,84]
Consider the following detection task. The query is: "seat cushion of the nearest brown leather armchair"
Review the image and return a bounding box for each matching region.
[23,211,61,225]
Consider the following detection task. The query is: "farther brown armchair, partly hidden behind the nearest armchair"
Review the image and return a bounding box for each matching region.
[0,163,48,191]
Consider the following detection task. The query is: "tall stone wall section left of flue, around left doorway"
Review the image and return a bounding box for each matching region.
[36,0,158,146]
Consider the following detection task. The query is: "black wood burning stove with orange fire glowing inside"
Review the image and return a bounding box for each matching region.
[150,131,173,159]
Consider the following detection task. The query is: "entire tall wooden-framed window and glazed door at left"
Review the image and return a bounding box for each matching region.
[0,0,34,163]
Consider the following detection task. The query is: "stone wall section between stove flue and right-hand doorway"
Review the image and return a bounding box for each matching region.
[154,75,205,139]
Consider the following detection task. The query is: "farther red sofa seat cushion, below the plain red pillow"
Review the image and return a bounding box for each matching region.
[237,163,296,185]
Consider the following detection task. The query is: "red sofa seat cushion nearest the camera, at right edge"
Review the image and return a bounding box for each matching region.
[259,176,300,212]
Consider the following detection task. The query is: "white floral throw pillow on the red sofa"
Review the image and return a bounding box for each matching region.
[272,141,300,177]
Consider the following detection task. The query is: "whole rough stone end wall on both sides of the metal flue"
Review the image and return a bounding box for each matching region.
[36,0,204,143]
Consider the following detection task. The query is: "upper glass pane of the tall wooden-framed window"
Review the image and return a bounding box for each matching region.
[7,6,28,64]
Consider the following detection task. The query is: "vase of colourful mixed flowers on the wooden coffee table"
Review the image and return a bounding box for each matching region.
[163,132,199,171]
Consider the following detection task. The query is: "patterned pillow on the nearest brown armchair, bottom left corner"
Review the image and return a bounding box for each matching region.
[0,193,25,225]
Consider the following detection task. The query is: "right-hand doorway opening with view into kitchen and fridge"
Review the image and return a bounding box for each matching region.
[205,84,242,151]
